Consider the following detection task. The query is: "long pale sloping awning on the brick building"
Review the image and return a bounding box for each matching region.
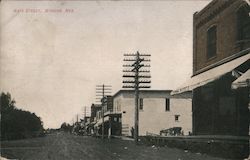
[171,53,250,95]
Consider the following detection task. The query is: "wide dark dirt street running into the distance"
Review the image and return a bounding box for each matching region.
[1,132,227,160]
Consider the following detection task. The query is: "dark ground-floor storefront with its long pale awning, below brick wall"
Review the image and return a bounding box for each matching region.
[172,54,250,136]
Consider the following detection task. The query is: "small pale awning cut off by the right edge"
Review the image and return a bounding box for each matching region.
[232,69,250,89]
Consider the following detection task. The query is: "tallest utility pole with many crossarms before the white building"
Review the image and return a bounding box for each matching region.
[123,51,151,144]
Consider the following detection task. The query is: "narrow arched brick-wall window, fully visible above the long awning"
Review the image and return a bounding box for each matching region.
[207,26,217,59]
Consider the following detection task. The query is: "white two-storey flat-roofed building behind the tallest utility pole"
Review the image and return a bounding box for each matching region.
[113,90,192,136]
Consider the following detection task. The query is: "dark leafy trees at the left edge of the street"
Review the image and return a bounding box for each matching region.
[0,93,44,140]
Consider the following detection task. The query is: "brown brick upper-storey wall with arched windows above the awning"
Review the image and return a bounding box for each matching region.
[193,0,250,75]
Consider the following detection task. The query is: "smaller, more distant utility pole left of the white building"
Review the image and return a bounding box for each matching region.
[96,84,112,139]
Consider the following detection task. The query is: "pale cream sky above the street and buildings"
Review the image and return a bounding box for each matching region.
[0,0,210,128]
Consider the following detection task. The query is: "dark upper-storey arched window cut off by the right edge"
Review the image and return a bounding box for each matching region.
[237,5,250,40]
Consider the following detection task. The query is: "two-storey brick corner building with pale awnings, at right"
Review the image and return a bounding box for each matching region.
[172,0,250,136]
